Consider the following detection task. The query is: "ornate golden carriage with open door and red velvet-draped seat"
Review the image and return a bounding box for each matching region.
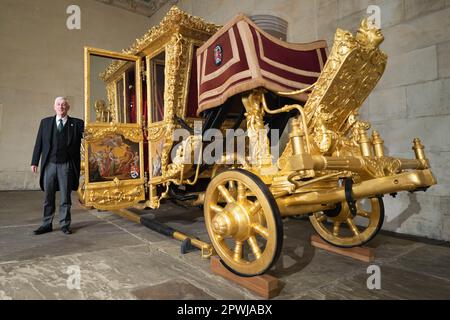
[79,7,436,276]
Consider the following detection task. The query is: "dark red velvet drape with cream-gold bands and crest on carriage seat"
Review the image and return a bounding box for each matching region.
[197,14,327,115]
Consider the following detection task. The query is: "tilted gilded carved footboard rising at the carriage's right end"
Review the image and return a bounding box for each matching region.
[304,20,387,135]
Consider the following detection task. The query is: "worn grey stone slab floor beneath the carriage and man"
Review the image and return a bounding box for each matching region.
[0,191,450,299]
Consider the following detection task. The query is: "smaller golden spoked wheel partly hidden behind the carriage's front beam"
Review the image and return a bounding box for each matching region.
[309,198,384,248]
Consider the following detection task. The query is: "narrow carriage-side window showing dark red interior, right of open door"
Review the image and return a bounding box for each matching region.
[150,51,165,122]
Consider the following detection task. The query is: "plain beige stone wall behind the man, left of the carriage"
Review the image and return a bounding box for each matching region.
[0,0,150,190]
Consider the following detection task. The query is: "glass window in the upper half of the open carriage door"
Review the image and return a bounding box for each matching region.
[89,55,137,123]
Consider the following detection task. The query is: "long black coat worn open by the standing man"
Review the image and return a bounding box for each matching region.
[31,116,84,191]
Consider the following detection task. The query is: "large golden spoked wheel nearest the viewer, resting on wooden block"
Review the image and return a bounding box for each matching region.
[204,169,283,277]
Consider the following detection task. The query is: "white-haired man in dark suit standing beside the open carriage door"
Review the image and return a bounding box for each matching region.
[31,97,84,234]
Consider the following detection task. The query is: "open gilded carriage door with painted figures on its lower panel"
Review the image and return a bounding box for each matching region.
[83,48,145,210]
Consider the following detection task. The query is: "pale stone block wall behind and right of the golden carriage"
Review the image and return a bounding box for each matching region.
[151,0,450,241]
